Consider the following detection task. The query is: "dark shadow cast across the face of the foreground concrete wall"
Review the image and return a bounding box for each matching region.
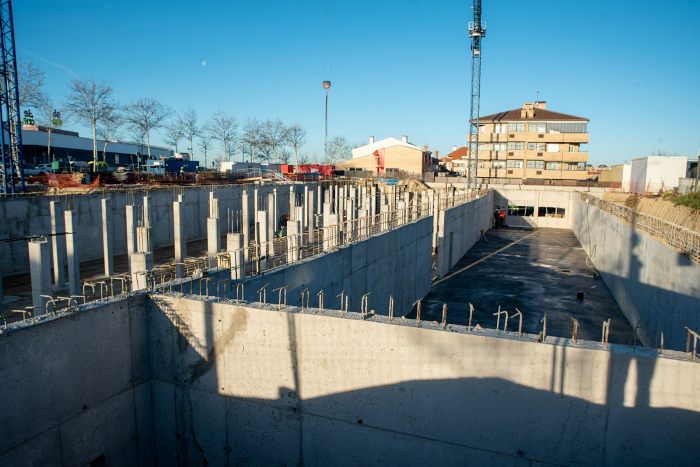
[150,302,700,465]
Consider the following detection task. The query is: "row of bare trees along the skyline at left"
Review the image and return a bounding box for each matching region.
[18,62,351,167]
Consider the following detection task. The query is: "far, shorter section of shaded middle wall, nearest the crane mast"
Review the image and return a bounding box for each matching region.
[436,190,494,277]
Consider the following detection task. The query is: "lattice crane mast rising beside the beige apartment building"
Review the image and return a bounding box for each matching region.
[467,0,486,189]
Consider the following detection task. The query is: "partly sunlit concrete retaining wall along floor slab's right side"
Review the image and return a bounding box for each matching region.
[572,195,700,350]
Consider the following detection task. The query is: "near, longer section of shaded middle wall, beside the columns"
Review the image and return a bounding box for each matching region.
[211,216,433,316]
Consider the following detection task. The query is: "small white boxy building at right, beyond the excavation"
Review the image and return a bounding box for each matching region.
[623,156,688,194]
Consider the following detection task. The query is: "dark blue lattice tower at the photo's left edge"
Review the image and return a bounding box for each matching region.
[0,0,24,194]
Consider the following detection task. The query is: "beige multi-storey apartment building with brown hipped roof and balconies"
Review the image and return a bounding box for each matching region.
[470,102,588,182]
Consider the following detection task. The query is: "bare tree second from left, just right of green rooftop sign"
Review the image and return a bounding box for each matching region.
[65,80,118,164]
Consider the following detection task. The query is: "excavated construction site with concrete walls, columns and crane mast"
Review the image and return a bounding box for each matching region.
[0,0,700,466]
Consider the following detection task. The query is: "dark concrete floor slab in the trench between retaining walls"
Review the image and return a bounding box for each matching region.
[416,228,633,344]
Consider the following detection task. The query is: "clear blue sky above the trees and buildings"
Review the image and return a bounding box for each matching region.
[9,0,700,164]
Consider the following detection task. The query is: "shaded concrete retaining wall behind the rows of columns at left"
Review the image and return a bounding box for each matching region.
[0,185,303,276]
